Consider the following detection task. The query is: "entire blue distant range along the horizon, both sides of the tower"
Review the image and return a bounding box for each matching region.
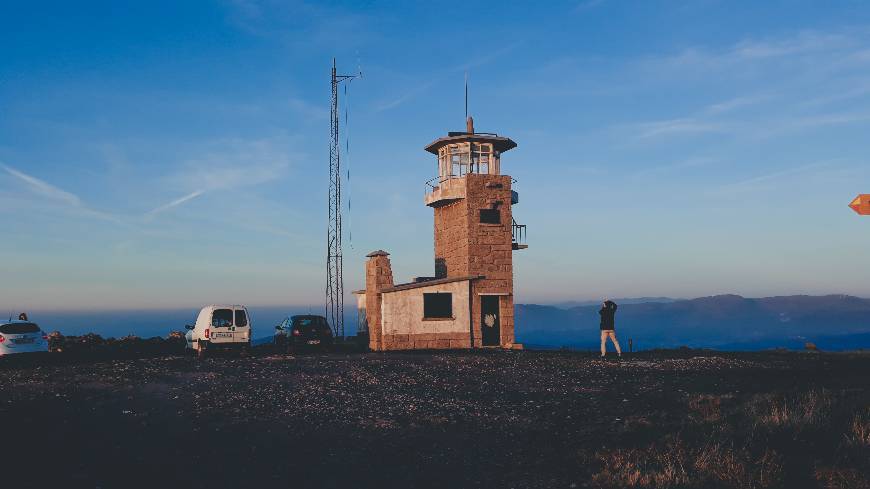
[18,295,870,350]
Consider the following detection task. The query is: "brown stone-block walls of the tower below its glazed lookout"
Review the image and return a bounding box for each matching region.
[435,174,514,347]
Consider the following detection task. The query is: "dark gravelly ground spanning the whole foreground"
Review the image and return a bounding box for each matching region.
[0,350,870,488]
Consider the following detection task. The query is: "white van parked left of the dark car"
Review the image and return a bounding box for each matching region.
[184,305,251,355]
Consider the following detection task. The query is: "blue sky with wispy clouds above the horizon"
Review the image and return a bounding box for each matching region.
[0,0,870,310]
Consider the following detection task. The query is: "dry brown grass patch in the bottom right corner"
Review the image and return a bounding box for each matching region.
[592,389,870,489]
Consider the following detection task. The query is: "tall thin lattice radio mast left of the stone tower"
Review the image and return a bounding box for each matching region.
[326,58,362,338]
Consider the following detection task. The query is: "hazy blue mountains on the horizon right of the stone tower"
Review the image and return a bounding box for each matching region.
[516,295,870,350]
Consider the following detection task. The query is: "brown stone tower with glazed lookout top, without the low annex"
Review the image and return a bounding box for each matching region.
[425,117,527,348]
